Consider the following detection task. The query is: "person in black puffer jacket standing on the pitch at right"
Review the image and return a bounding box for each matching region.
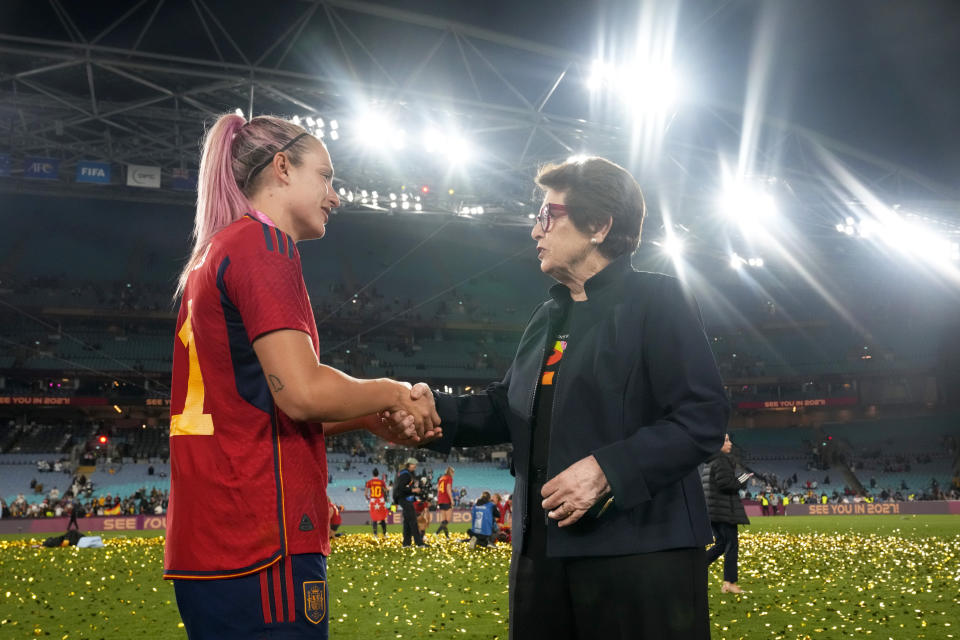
[700,435,753,593]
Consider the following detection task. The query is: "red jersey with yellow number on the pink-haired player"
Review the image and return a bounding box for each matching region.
[164,217,330,579]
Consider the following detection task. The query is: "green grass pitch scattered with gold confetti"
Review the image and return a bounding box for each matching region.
[0,516,960,640]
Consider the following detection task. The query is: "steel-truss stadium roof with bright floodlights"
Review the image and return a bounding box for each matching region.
[0,0,960,240]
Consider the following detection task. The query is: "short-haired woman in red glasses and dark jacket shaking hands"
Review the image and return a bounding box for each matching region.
[394,158,729,640]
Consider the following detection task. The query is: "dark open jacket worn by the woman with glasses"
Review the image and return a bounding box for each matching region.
[428,255,729,557]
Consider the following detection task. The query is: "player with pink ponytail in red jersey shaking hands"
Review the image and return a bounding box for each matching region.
[164,115,439,640]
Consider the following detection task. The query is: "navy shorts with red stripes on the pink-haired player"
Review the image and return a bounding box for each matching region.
[173,553,330,640]
